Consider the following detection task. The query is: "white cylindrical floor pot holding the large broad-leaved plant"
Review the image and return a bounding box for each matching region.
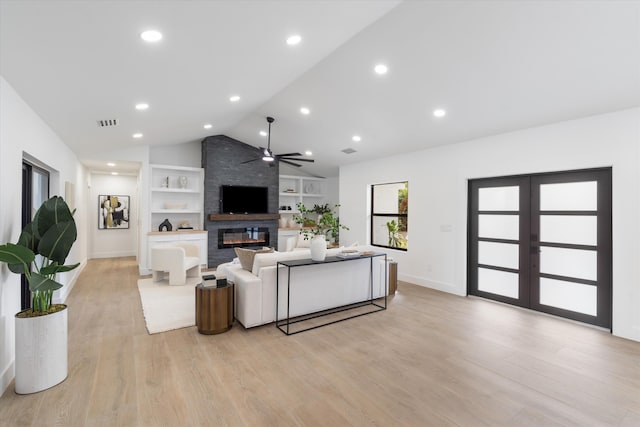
[15,307,68,394]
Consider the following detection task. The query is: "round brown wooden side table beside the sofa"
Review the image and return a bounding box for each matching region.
[196,282,233,335]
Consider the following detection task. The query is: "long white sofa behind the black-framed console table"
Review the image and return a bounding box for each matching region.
[216,247,388,328]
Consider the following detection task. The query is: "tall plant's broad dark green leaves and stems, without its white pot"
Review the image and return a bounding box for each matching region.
[0,196,80,315]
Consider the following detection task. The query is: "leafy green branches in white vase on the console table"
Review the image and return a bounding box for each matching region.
[293,203,349,261]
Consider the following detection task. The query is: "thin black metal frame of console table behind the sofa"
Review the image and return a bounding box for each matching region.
[276,253,389,335]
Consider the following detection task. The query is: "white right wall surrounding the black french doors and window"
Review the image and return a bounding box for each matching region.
[340,108,640,341]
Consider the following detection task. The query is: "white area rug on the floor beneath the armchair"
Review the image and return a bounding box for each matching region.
[138,278,196,334]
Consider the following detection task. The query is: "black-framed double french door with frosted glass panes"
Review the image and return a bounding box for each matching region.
[468,168,612,328]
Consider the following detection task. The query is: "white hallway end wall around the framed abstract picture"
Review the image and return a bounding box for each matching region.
[87,174,139,258]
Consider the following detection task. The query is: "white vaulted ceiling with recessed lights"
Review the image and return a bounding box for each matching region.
[0,0,640,176]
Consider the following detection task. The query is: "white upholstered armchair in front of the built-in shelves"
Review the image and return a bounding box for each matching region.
[151,243,202,285]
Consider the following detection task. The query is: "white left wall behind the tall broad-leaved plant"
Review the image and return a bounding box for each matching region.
[0,77,87,392]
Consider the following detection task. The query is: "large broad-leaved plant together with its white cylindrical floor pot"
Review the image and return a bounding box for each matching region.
[0,196,80,394]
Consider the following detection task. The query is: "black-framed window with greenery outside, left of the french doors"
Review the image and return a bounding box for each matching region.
[371,181,409,251]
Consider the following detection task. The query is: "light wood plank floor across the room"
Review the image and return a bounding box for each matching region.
[0,258,640,427]
